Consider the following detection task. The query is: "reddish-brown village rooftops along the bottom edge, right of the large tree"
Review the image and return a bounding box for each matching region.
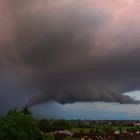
[52,130,140,140]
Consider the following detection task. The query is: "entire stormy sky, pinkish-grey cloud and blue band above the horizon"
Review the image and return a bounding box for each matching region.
[0,0,140,119]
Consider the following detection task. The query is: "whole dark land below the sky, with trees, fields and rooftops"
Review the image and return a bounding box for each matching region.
[0,107,140,140]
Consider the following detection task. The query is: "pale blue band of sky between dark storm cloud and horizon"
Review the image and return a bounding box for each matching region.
[31,102,140,120]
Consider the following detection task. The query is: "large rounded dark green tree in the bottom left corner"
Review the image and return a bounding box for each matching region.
[0,108,42,140]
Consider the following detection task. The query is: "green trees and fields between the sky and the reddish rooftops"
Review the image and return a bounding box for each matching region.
[0,107,140,140]
